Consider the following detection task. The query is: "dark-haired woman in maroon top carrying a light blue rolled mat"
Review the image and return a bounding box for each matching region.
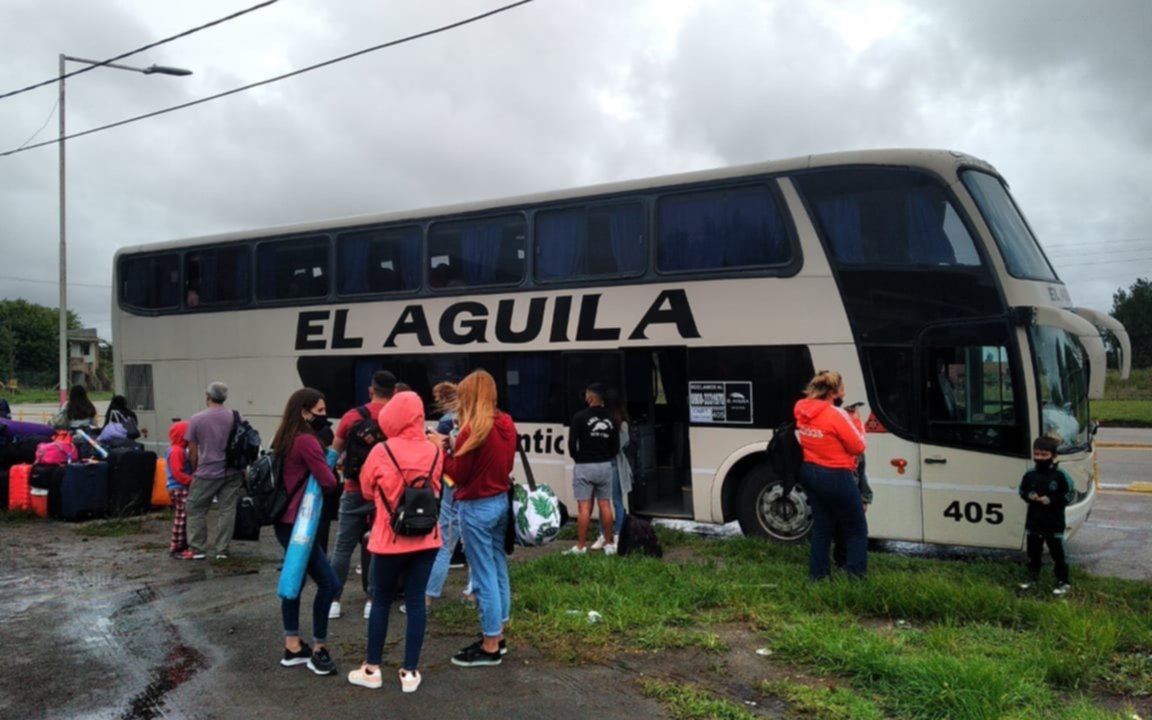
[272,387,339,675]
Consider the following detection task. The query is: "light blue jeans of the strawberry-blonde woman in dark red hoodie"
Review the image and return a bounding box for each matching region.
[456,493,511,637]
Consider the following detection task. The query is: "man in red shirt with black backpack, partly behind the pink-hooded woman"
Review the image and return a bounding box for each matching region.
[328,370,396,619]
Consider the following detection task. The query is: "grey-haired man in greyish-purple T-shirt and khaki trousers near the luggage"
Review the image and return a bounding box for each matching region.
[180,380,244,560]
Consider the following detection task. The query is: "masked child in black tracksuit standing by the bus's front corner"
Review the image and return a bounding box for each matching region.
[1020,437,1076,596]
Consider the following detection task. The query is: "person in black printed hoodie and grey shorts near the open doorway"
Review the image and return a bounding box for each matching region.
[564,382,620,555]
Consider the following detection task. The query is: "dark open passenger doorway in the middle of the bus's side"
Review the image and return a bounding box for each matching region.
[624,348,692,517]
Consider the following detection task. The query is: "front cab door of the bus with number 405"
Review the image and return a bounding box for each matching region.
[918,321,1030,547]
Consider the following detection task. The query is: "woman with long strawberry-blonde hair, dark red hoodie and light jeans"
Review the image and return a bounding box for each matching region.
[433,370,518,667]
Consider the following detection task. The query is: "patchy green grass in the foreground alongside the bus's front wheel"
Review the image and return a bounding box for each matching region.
[513,529,1152,720]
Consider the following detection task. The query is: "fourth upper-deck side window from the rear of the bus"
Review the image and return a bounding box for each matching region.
[336,226,422,295]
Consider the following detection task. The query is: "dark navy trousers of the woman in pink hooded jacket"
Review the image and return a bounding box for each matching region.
[367,550,437,670]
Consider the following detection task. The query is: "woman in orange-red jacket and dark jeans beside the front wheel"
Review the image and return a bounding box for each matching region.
[794,370,867,579]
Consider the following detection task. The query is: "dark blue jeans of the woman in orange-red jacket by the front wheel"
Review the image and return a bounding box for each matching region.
[799,462,867,579]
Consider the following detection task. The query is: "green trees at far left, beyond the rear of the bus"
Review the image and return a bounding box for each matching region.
[0,300,81,385]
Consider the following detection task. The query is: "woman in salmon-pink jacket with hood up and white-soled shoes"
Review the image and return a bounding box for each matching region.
[348,391,444,692]
